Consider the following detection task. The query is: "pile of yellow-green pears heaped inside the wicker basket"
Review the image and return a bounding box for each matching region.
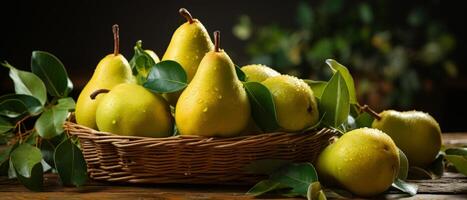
[75,8,319,137]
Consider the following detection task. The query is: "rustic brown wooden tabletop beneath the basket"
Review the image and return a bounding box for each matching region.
[0,133,467,200]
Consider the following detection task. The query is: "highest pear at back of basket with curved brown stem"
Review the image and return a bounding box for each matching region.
[162,8,214,105]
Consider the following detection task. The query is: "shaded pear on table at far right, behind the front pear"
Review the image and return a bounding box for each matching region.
[372,110,442,167]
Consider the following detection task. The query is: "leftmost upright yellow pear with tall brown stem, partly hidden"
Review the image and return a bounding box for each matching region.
[75,25,135,129]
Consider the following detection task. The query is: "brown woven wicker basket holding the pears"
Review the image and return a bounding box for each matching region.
[65,122,337,185]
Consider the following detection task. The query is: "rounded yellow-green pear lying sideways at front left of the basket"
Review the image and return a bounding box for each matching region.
[96,83,173,137]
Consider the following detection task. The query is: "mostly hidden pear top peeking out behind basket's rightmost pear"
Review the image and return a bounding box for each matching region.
[241,64,281,82]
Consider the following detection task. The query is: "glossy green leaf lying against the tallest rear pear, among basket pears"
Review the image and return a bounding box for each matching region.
[143,60,187,93]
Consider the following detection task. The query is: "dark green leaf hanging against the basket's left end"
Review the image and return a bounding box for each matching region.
[54,138,88,186]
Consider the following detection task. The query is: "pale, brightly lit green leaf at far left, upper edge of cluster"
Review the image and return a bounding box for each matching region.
[2,62,47,105]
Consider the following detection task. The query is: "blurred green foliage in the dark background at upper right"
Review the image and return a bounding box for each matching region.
[232,0,459,110]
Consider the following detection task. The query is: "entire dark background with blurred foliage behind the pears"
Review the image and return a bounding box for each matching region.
[0,0,467,132]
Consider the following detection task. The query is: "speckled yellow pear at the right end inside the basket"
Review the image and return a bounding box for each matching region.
[262,75,319,132]
